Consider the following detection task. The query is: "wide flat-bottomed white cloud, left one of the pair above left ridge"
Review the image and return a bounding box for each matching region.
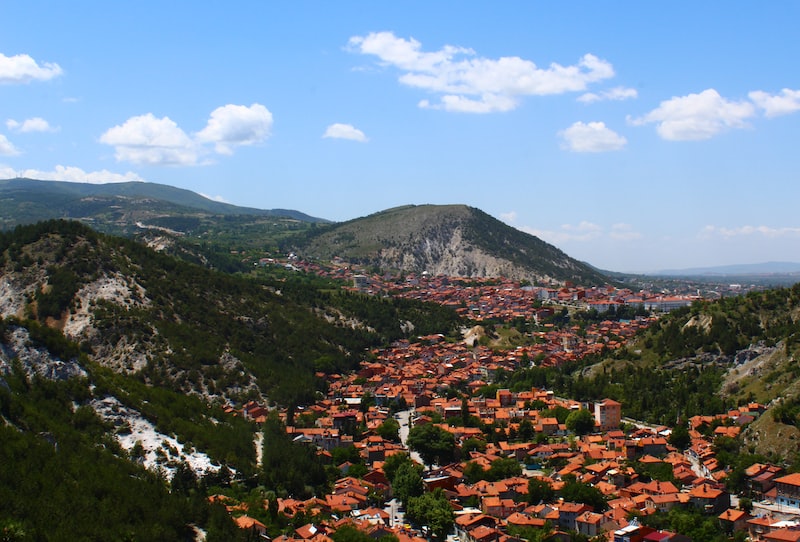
[100,113,201,165]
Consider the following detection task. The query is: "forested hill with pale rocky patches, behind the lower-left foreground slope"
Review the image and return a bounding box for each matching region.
[0,221,456,404]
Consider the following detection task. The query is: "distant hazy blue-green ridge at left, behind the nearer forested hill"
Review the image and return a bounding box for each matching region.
[0,179,327,272]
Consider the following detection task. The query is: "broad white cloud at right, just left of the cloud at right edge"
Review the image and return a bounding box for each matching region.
[628,88,755,141]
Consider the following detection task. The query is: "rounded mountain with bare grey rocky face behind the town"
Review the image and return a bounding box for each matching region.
[294,205,608,285]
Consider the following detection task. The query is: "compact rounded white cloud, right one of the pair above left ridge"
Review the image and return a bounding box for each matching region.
[196,103,272,154]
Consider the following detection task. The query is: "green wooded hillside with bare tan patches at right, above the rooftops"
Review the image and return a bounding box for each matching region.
[500,284,800,462]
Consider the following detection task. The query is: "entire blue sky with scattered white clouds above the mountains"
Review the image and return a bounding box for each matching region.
[0,0,800,272]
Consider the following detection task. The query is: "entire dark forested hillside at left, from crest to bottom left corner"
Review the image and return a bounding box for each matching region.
[0,221,458,542]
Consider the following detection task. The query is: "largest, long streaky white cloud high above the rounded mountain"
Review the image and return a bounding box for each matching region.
[348,32,614,113]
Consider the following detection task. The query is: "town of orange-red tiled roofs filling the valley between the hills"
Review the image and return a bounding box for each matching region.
[212,262,800,542]
